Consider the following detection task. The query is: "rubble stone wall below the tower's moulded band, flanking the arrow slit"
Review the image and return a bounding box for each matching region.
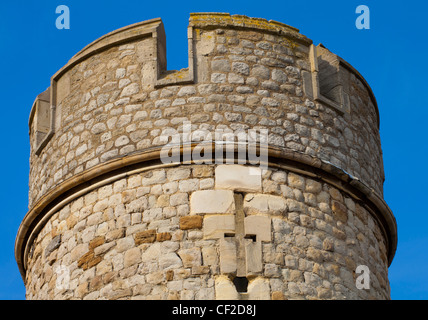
[26,165,390,299]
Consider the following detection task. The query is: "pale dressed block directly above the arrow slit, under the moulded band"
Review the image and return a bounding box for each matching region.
[215,164,262,192]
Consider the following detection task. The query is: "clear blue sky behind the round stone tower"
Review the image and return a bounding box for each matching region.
[0,0,428,299]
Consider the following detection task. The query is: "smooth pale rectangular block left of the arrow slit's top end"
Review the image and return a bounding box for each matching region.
[190,190,235,214]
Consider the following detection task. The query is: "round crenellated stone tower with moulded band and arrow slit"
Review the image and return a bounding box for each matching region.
[15,13,397,300]
